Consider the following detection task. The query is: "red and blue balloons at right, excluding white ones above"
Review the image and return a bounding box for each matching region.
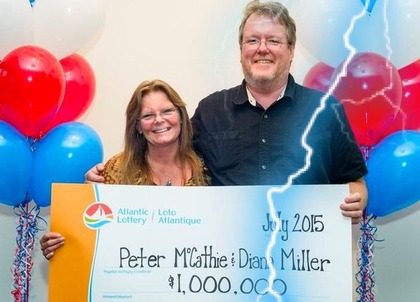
[303,53,420,222]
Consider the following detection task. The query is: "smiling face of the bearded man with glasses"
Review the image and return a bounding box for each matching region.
[241,14,294,87]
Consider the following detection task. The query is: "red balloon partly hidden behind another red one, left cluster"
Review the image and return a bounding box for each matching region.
[43,53,96,133]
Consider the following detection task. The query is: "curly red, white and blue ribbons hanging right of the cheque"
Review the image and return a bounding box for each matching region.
[356,211,380,302]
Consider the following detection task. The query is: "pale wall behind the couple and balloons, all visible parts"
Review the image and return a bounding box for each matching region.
[0,0,420,302]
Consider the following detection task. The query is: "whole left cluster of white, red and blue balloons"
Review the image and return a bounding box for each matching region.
[0,0,104,207]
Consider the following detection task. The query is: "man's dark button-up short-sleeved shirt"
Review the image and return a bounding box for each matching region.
[191,75,367,185]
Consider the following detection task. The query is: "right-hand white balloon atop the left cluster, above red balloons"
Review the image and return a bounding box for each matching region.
[33,0,105,59]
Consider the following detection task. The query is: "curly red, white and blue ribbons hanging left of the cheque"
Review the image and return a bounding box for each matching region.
[11,203,45,302]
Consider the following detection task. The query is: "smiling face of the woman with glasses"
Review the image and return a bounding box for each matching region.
[138,91,181,147]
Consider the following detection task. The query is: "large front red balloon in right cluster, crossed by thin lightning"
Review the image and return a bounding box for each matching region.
[332,53,402,147]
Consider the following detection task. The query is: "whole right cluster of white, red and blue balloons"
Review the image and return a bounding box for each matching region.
[290,0,420,217]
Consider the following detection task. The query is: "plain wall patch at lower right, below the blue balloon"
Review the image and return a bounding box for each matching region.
[374,202,420,302]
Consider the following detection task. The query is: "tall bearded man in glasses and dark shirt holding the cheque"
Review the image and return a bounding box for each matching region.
[86,1,367,224]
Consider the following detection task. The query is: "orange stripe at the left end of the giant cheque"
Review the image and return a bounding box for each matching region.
[48,184,96,302]
